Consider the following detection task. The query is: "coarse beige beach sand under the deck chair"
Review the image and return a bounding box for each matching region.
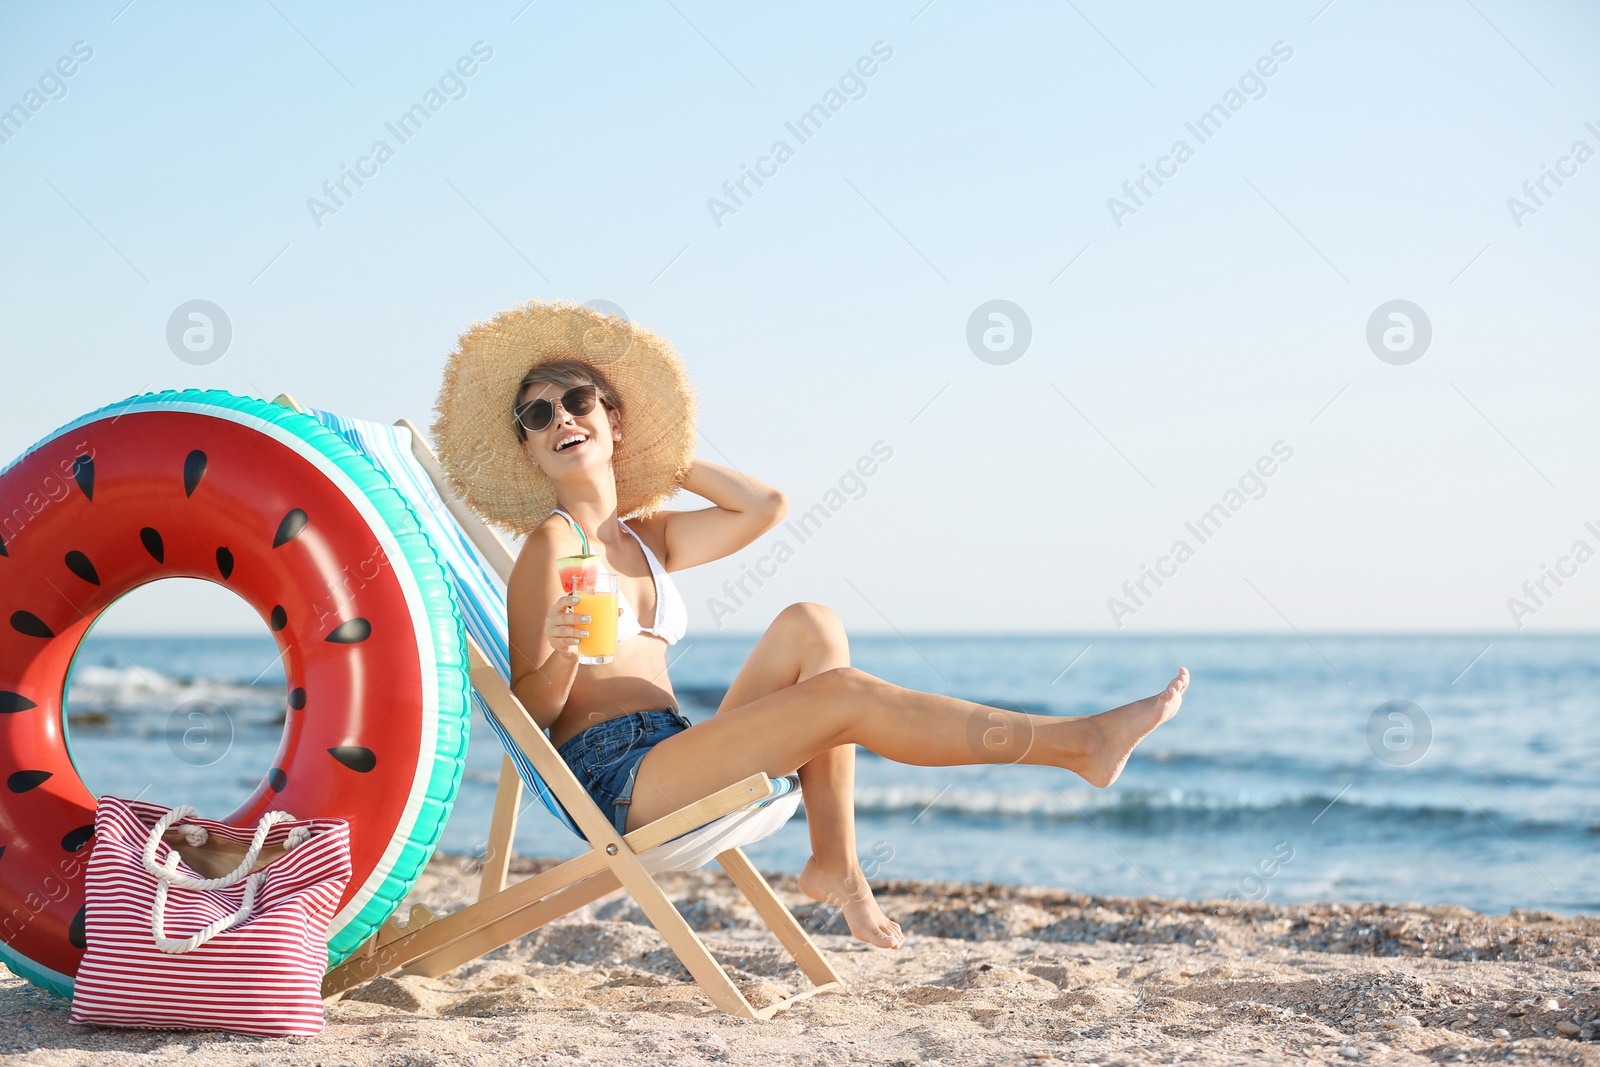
[0,857,1600,1067]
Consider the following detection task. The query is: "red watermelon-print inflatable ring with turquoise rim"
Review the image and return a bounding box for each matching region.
[0,390,470,995]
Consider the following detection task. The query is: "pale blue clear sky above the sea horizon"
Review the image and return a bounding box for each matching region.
[0,0,1600,633]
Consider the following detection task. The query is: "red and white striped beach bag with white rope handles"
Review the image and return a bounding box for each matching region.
[70,797,350,1035]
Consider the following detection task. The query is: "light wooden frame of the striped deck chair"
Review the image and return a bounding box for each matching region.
[277,403,845,1019]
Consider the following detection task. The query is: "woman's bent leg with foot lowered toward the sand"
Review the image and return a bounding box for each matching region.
[694,601,906,949]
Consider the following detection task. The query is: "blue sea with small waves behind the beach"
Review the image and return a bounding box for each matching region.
[56,632,1600,915]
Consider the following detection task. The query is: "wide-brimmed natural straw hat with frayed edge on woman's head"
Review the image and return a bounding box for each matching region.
[432,301,699,534]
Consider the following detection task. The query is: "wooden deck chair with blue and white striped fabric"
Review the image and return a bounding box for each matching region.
[277,395,843,1019]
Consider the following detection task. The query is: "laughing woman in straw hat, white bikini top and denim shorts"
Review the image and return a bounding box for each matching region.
[434,304,1189,949]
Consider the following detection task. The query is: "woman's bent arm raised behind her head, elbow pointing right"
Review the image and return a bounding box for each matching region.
[646,459,789,571]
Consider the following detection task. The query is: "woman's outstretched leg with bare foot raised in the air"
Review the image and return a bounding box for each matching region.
[629,627,1189,827]
